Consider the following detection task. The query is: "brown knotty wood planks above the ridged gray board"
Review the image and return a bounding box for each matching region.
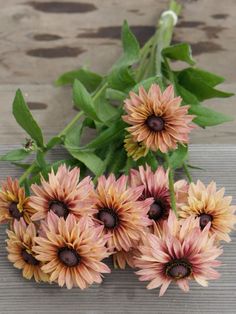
[0,0,236,144]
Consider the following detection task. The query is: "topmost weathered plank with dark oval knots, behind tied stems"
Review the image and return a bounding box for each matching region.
[0,0,236,84]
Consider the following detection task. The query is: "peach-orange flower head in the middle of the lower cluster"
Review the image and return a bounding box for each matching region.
[95,174,152,252]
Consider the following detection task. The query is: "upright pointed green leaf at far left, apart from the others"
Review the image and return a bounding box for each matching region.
[13,89,43,147]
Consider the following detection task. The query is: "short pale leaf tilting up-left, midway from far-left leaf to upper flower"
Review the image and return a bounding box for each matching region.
[73,80,99,121]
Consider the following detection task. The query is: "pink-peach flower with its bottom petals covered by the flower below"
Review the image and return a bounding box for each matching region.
[30,165,94,220]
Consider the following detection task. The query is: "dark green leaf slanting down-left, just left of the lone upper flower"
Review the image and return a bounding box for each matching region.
[85,120,126,149]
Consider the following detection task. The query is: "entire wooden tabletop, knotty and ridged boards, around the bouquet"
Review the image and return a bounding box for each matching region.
[0,0,236,314]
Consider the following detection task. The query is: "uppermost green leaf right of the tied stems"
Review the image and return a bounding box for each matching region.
[162,43,195,65]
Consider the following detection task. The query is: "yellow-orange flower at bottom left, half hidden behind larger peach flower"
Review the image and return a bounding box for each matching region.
[7,218,48,282]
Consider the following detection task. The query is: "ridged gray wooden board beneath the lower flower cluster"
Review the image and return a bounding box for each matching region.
[0,145,236,314]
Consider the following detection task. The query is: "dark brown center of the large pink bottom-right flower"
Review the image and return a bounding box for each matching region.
[166,260,192,280]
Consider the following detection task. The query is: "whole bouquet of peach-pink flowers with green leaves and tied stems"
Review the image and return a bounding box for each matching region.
[0,1,236,295]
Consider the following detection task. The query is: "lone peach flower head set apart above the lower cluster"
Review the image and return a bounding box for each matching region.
[123,84,193,153]
